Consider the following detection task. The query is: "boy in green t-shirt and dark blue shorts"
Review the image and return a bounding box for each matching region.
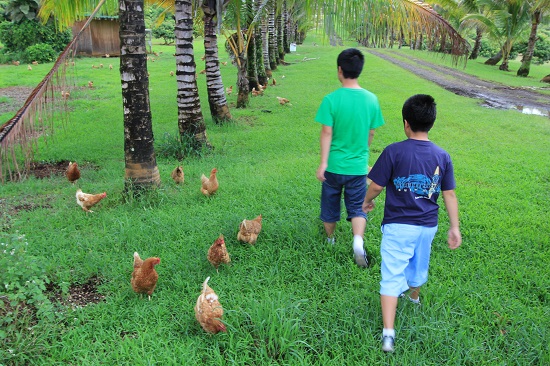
[315,48,384,267]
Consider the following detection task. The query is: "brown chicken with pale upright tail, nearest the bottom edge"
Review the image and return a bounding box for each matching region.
[195,277,227,334]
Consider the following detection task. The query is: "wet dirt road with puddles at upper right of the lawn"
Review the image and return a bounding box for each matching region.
[368,49,550,117]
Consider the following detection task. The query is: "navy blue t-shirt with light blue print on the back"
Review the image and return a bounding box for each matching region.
[368,139,456,227]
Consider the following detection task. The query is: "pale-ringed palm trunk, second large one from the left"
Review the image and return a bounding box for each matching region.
[174,0,210,150]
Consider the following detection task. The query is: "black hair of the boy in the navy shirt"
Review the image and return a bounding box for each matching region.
[401,94,437,132]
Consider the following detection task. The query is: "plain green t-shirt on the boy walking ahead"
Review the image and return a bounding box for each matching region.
[315,88,384,175]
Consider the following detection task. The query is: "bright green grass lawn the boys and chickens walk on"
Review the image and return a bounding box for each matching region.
[0,36,550,365]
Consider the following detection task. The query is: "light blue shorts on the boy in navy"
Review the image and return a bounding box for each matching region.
[380,224,437,296]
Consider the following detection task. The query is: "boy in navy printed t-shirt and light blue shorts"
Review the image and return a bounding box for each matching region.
[363,94,462,352]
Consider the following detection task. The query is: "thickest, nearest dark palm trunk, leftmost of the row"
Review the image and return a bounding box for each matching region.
[119,0,160,192]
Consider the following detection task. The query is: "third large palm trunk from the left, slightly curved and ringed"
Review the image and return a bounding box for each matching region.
[202,1,232,123]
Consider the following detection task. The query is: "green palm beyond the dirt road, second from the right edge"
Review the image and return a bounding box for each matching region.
[463,0,530,71]
